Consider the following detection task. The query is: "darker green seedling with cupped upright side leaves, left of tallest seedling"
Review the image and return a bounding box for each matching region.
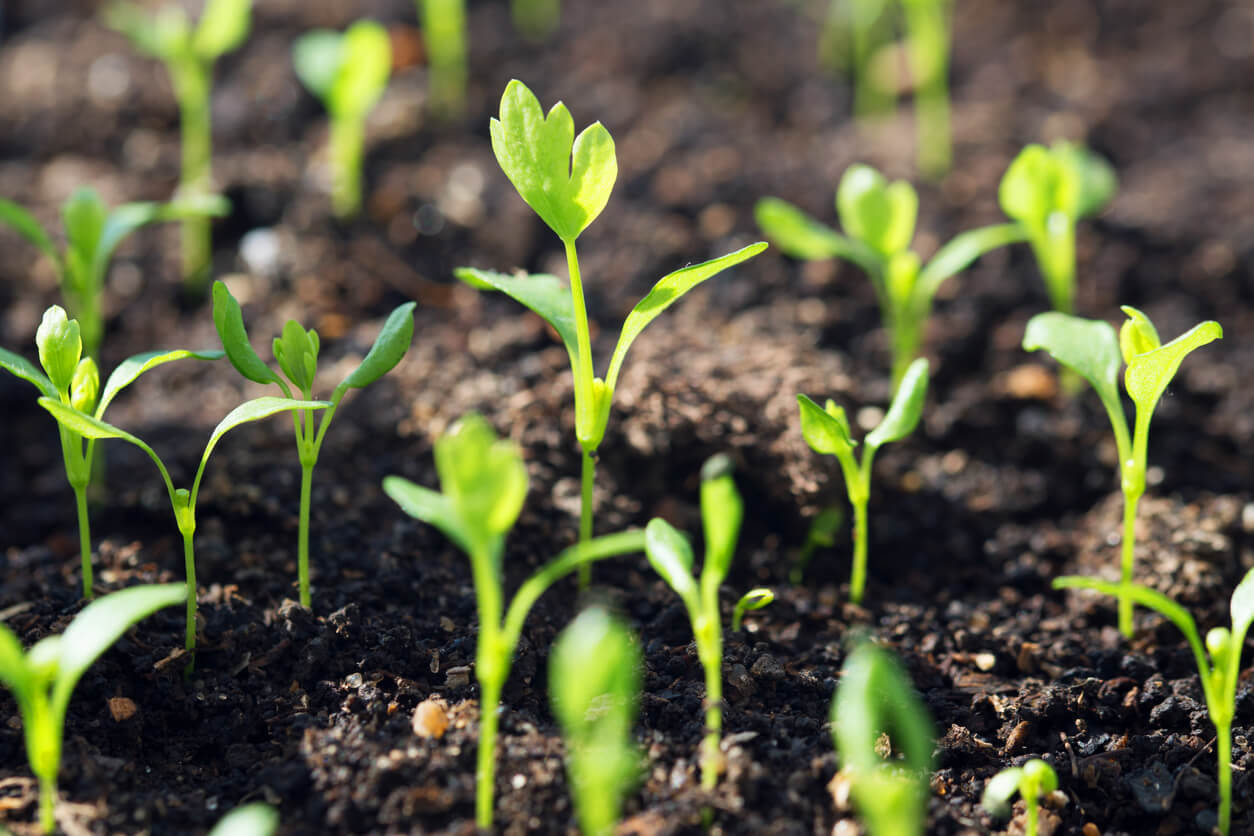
[213,282,414,607]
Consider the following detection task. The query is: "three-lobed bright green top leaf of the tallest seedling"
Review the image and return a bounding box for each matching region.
[490,79,618,243]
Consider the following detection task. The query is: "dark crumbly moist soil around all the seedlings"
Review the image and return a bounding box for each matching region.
[0,0,1254,836]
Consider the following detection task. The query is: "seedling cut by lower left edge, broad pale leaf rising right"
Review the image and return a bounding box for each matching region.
[0,584,183,833]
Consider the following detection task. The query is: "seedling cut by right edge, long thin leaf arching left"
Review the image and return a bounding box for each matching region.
[1053,569,1254,836]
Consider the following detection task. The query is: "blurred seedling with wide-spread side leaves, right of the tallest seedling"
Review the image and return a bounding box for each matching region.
[754,165,1023,390]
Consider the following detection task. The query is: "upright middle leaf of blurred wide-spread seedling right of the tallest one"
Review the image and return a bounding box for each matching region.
[836,165,919,258]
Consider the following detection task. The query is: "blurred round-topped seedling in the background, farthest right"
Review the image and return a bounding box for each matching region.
[997,142,1119,313]
